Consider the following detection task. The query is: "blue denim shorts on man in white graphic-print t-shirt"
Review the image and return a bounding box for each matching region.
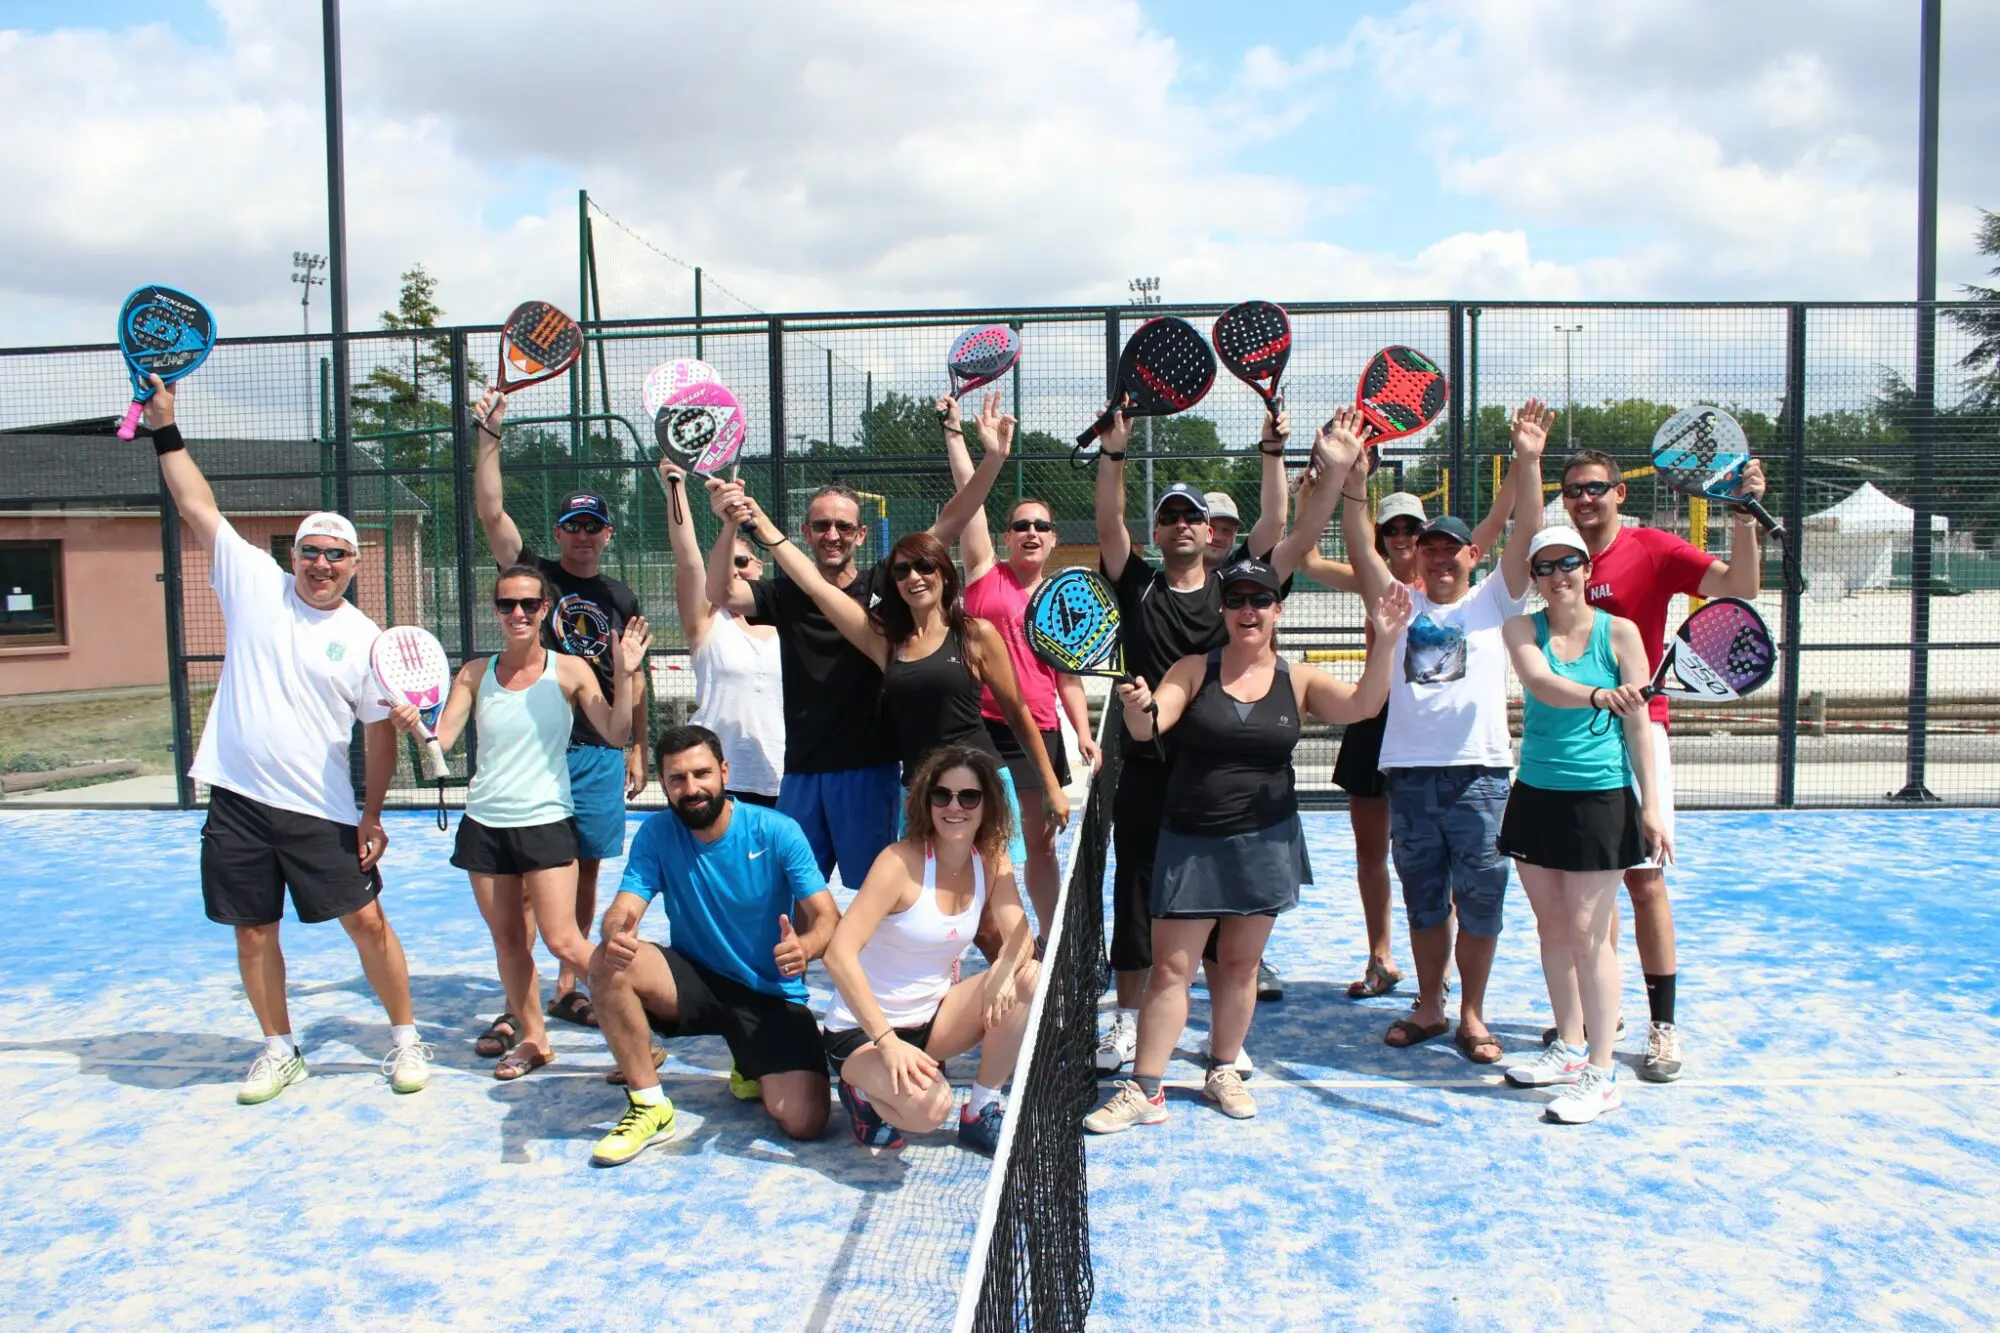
[1382,765,1508,939]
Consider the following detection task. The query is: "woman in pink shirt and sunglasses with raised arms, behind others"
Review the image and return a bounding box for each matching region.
[938,390,1098,933]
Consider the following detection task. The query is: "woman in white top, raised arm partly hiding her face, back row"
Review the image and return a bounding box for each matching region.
[660,458,784,807]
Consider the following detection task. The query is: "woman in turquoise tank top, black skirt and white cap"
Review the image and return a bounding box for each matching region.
[1500,528,1674,1125]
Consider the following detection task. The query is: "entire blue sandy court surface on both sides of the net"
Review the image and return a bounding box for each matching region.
[0,813,2000,1329]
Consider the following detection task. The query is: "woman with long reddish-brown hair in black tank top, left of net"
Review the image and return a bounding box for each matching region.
[720,498,1070,824]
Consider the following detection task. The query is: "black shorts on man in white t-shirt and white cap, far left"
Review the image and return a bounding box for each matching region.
[202,787,382,925]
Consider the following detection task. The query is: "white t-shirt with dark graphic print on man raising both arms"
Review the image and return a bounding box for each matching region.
[1380,570,1528,771]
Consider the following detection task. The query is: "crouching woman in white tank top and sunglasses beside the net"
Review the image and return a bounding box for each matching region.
[824,745,1038,1157]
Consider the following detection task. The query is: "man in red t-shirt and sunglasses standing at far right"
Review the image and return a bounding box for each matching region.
[1562,448,1764,1083]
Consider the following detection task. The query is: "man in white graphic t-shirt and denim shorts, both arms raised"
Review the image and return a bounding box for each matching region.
[1334,398,1552,1065]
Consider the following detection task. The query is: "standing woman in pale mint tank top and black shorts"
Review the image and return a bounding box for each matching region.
[390,564,652,1079]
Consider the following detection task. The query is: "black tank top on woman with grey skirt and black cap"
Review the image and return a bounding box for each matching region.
[1164,648,1298,837]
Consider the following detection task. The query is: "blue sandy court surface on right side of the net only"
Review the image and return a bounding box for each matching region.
[1090,811,2000,1329]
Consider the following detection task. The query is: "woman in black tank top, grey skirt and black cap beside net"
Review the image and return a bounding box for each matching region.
[1084,560,1410,1135]
